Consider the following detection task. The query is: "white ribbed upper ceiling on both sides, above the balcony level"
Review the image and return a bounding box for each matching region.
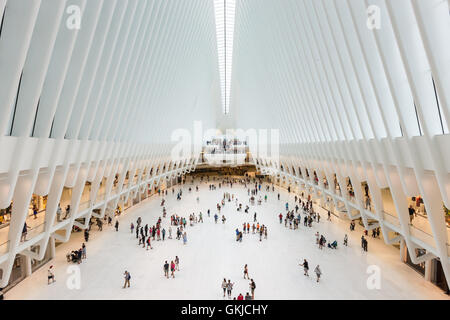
[0,0,450,143]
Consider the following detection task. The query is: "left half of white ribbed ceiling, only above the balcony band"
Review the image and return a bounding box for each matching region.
[0,0,221,143]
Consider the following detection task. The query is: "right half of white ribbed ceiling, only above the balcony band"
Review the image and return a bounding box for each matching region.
[230,0,450,143]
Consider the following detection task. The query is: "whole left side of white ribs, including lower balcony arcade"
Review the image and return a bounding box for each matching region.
[0,0,221,287]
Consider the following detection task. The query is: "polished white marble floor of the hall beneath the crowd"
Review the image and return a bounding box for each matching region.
[5,183,449,300]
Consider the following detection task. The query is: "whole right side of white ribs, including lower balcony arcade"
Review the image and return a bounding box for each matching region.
[230,0,450,283]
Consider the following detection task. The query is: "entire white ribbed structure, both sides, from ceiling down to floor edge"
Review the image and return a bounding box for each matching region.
[0,0,450,287]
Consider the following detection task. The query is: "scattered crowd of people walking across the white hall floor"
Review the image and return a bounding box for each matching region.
[34,172,380,300]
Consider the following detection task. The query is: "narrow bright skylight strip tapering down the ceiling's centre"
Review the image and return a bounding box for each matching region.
[214,0,236,114]
